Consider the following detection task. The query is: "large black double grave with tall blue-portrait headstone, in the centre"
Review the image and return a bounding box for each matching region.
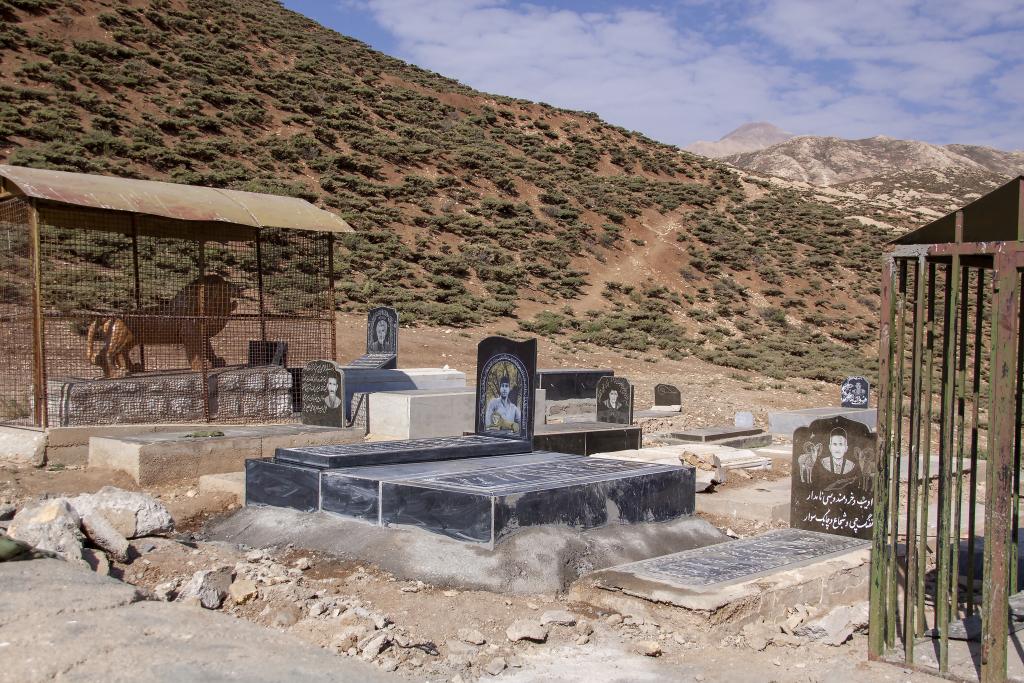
[246,337,694,547]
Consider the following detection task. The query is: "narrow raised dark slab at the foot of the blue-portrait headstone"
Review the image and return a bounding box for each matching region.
[274,434,530,469]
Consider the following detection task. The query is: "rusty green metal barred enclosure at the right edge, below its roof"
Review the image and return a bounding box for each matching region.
[868,232,1024,683]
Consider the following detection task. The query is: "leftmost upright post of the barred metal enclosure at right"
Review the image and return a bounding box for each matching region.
[867,257,898,657]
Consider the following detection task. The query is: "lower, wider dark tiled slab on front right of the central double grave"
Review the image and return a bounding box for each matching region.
[324,452,694,545]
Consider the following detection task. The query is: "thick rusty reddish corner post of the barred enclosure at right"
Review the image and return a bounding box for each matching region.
[980,251,1019,683]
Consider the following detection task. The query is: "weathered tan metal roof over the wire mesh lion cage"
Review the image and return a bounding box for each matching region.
[0,164,352,232]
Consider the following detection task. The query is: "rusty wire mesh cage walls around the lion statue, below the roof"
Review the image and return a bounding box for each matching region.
[0,197,335,426]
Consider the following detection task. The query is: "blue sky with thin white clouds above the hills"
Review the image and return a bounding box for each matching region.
[284,0,1024,150]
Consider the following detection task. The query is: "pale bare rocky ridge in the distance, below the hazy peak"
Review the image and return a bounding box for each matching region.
[722,135,1024,191]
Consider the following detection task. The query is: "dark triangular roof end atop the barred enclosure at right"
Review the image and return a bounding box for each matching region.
[892,175,1024,245]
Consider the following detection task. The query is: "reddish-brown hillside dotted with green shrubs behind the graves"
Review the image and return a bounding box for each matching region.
[0,0,888,381]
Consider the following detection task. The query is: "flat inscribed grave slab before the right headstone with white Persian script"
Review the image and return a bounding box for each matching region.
[600,528,869,590]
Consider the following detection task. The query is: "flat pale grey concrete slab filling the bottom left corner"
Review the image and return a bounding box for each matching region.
[0,559,396,683]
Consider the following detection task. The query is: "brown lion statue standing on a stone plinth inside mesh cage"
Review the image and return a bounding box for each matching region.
[85,274,243,377]
